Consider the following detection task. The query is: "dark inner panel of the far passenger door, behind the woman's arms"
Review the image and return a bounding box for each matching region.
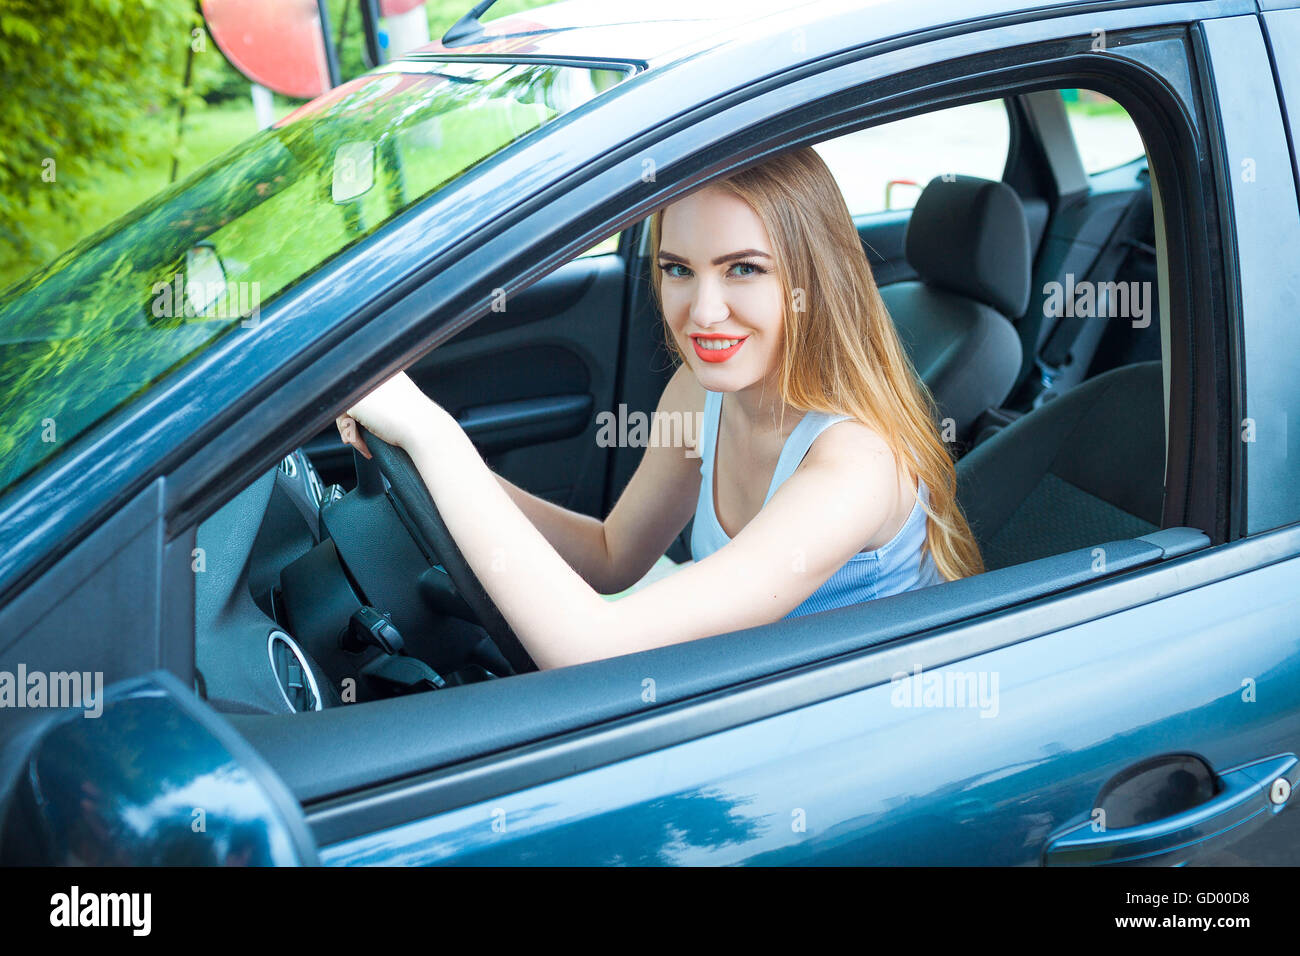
[306,254,624,516]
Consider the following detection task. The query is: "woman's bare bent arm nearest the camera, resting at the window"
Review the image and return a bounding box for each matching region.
[348,376,897,667]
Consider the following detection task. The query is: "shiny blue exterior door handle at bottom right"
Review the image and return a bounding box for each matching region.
[1044,753,1297,866]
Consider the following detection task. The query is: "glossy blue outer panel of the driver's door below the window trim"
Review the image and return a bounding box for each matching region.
[321,546,1300,865]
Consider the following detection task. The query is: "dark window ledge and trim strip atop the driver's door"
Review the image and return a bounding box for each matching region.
[230,528,1206,806]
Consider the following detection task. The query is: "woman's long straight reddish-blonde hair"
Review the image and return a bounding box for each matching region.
[650,147,984,581]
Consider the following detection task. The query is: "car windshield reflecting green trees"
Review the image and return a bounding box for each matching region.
[0,61,625,493]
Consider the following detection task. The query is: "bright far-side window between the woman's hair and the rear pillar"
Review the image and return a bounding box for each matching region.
[815,100,1011,216]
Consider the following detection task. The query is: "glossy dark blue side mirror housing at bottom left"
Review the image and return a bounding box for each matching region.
[0,671,320,868]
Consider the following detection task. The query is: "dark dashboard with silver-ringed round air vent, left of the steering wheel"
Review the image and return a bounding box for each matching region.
[192,449,512,714]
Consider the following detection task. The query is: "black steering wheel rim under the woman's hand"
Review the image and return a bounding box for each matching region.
[355,424,537,674]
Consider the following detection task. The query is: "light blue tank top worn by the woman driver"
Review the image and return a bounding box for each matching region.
[690,392,943,618]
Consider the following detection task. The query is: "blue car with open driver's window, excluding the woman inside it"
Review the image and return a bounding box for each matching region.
[0,0,1300,865]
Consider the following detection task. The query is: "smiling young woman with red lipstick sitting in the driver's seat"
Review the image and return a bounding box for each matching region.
[338,148,983,669]
